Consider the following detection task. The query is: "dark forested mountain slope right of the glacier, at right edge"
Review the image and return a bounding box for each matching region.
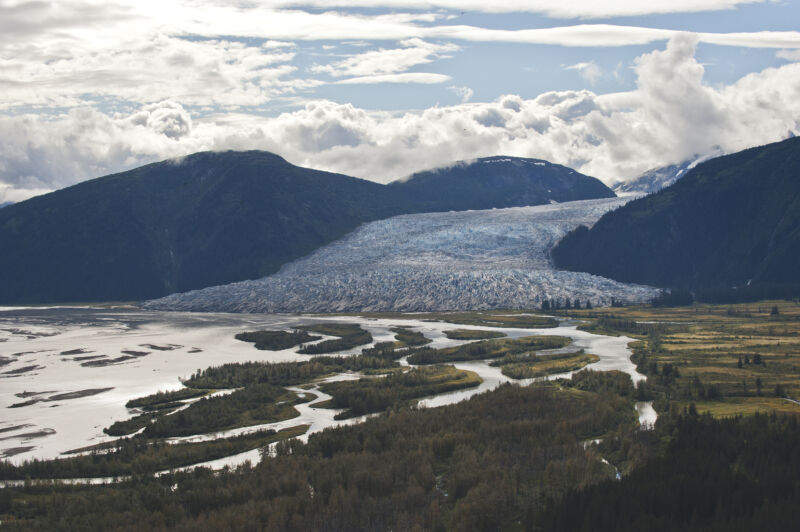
[552,138,800,290]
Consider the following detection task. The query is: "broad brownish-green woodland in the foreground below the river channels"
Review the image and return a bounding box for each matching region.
[0,385,635,531]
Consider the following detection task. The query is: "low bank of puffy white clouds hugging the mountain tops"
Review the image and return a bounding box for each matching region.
[0,34,800,201]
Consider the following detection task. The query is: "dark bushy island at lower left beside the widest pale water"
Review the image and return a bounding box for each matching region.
[142,383,313,438]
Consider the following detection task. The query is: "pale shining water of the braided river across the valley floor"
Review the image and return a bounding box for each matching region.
[0,308,642,465]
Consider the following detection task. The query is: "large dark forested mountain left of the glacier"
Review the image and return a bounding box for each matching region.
[0,151,607,304]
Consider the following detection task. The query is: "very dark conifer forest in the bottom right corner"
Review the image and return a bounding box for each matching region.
[541,409,800,532]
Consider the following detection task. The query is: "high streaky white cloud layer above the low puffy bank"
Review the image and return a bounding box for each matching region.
[0,0,800,112]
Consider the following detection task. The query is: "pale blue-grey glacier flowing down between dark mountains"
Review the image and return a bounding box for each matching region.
[144,198,658,313]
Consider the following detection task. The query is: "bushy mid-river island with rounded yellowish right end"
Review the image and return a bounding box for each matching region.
[320,366,482,419]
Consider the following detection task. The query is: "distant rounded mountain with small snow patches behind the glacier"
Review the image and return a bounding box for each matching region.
[389,156,615,212]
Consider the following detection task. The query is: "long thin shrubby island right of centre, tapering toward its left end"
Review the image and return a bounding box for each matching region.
[408,336,570,364]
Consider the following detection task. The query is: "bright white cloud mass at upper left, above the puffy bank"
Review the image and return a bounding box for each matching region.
[0,34,305,109]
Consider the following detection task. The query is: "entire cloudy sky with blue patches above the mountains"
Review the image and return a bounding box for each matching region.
[0,0,800,203]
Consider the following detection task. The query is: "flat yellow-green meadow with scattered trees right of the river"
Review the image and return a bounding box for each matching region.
[571,301,800,416]
